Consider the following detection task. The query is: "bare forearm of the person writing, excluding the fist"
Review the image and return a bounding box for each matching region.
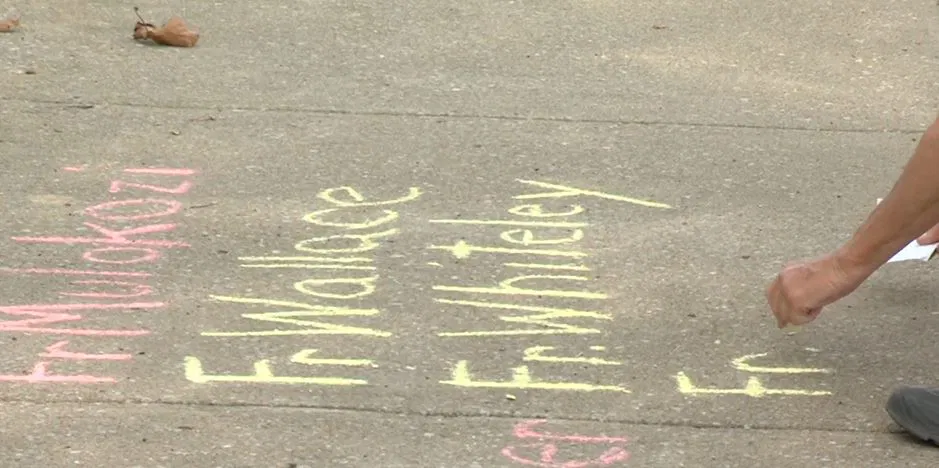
[838,119,939,277]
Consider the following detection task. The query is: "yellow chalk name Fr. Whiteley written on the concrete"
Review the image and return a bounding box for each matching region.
[428,180,671,398]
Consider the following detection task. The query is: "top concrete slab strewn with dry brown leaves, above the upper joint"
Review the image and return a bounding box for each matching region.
[0,0,939,130]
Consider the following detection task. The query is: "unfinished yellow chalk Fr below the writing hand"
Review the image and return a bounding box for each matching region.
[675,353,831,398]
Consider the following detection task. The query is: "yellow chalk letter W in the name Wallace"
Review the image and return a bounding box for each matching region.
[201,296,391,337]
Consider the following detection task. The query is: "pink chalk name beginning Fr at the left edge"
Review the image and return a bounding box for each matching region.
[0,167,196,384]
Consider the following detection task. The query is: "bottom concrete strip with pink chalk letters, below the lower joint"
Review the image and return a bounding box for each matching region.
[0,404,935,468]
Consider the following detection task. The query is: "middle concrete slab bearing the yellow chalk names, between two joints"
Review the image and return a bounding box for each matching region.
[2,105,935,430]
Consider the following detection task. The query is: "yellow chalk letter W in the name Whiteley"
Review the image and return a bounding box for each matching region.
[434,299,613,336]
